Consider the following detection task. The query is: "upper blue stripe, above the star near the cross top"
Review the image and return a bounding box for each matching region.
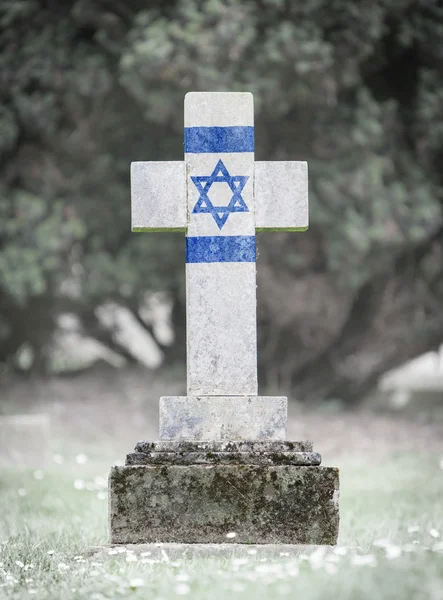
[185,127,254,154]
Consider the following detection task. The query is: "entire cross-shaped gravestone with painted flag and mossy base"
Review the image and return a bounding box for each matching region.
[109,92,339,544]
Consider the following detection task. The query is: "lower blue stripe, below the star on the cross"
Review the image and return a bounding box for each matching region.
[186,235,256,263]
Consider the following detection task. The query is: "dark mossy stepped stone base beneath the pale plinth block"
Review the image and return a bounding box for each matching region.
[109,441,339,545]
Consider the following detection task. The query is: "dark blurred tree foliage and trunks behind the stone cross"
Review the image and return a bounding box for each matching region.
[0,0,443,402]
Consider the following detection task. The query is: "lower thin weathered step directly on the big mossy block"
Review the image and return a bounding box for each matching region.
[126,452,321,466]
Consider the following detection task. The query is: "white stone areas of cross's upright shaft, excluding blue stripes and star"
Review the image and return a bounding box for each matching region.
[185,93,258,396]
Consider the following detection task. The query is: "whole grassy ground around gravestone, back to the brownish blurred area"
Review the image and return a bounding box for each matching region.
[0,372,443,600]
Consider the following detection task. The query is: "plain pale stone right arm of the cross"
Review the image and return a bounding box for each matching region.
[254,161,309,231]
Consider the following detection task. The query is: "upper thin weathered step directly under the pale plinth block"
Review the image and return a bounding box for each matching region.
[134,440,312,453]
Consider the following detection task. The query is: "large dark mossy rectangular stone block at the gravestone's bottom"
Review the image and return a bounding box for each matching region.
[109,465,339,544]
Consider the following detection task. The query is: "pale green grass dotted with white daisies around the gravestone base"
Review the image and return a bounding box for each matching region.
[0,452,443,600]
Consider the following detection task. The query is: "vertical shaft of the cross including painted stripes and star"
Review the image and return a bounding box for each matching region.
[185,93,257,396]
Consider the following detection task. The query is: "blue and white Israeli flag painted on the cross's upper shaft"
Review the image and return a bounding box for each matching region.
[185,93,255,262]
